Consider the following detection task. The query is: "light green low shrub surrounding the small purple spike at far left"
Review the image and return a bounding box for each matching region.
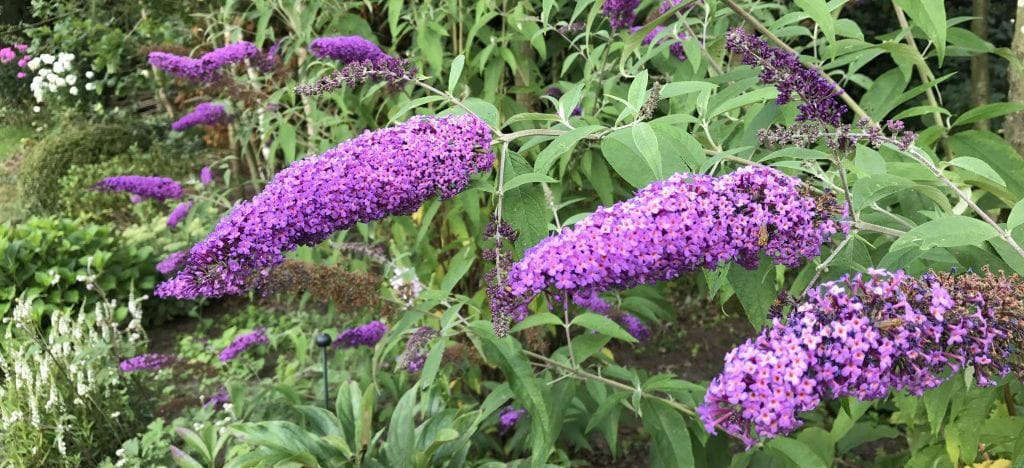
[57,140,201,225]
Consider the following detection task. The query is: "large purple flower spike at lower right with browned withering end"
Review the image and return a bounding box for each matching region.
[698,269,1024,445]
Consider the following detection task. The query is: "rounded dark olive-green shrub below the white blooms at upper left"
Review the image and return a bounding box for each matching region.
[17,123,155,214]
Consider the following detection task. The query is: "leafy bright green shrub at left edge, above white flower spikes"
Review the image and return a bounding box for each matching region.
[0,217,159,320]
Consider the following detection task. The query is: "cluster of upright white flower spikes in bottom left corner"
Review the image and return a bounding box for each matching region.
[0,274,146,455]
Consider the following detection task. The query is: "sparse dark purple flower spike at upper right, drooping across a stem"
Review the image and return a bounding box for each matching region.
[725,28,847,127]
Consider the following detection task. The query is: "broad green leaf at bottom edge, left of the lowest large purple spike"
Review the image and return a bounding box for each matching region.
[640,398,695,468]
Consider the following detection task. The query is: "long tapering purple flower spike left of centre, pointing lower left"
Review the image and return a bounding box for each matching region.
[157,115,494,299]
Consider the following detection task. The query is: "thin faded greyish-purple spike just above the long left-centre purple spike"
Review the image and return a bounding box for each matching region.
[295,55,416,96]
